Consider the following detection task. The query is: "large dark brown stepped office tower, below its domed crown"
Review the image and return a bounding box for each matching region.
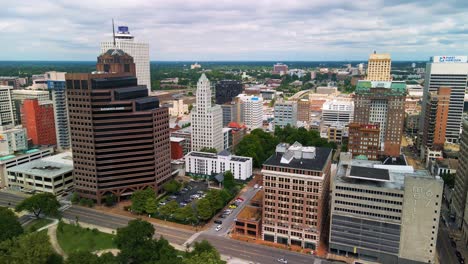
[66,50,171,203]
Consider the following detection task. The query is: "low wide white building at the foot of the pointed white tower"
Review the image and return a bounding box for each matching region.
[185,150,252,180]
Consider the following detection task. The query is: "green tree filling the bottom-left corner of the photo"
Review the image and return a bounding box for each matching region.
[0,232,60,264]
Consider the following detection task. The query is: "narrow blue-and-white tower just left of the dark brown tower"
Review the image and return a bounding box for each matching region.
[46,72,71,151]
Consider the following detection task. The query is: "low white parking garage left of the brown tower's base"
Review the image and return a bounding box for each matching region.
[7,152,73,195]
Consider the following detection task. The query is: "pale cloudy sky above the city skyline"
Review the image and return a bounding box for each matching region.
[0,0,468,61]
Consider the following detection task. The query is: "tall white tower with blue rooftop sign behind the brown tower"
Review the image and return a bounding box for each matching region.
[101,26,151,92]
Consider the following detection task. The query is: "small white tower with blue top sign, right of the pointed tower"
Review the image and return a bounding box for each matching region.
[238,94,263,130]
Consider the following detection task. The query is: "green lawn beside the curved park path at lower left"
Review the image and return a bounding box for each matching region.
[57,223,115,254]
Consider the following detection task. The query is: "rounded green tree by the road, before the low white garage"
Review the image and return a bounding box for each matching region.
[15,193,60,218]
